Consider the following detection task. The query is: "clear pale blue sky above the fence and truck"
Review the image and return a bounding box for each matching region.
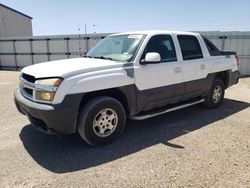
[0,0,250,35]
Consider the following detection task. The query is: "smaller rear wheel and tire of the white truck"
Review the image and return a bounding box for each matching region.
[204,78,225,109]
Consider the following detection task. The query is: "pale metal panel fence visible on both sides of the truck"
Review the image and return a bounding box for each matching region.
[0,32,250,75]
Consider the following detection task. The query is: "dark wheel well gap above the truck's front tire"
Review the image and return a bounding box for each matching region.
[78,88,129,114]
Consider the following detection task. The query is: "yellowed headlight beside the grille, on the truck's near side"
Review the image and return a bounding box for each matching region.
[33,78,62,102]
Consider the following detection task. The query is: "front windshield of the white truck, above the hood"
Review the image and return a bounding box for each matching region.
[86,34,143,61]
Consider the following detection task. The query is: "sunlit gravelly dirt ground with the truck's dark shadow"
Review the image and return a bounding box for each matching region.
[0,71,250,187]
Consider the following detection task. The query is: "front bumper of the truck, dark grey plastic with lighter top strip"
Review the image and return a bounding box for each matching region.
[14,89,83,134]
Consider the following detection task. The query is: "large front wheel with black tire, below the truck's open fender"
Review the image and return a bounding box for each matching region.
[77,96,126,147]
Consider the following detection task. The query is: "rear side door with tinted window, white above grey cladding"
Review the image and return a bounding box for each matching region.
[177,35,207,100]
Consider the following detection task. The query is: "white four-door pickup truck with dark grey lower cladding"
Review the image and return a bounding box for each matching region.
[14,31,240,146]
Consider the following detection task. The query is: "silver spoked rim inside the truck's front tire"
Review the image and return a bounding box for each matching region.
[93,108,118,137]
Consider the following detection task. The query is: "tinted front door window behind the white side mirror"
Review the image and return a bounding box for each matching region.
[141,35,177,62]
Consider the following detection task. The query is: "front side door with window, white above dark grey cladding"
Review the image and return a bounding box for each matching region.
[135,35,183,110]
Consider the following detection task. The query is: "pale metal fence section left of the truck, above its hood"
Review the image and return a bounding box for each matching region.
[0,34,106,69]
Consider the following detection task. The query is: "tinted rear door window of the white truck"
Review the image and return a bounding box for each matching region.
[177,35,203,60]
